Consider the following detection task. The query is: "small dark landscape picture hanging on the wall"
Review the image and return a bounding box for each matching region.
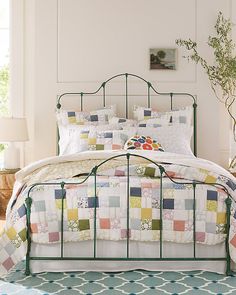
[149,48,177,70]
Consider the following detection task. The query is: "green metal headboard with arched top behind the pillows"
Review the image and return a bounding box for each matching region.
[57,73,197,156]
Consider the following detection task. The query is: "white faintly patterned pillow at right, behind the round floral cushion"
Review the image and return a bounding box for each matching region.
[137,124,193,156]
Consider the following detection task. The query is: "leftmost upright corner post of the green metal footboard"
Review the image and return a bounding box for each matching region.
[25,190,32,276]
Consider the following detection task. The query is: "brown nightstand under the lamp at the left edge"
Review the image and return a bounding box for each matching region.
[0,169,19,220]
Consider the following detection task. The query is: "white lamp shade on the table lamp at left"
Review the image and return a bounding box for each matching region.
[0,118,28,142]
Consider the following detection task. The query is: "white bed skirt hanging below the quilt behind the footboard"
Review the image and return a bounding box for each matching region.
[30,240,232,273]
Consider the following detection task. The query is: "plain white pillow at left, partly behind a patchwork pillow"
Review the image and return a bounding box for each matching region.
[58,124,121,156]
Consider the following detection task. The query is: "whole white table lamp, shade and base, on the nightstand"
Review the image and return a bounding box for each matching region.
[0,117,28,169]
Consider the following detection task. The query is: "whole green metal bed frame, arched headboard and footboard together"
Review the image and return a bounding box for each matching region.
[25,73,233,275]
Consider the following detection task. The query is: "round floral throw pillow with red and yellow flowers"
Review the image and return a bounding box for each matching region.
[124,135,164,152]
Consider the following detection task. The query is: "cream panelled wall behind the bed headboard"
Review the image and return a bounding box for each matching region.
[13,0,231,166]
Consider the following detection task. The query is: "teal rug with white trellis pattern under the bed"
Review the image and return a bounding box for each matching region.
[0,262,236,295]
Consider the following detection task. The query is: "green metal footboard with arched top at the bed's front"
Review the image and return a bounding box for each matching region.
[25,153,232,275]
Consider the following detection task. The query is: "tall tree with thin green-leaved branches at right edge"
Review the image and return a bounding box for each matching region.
[176,12,236,171]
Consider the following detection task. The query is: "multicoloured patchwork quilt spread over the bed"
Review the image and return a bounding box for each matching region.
[0,151,236,275]
